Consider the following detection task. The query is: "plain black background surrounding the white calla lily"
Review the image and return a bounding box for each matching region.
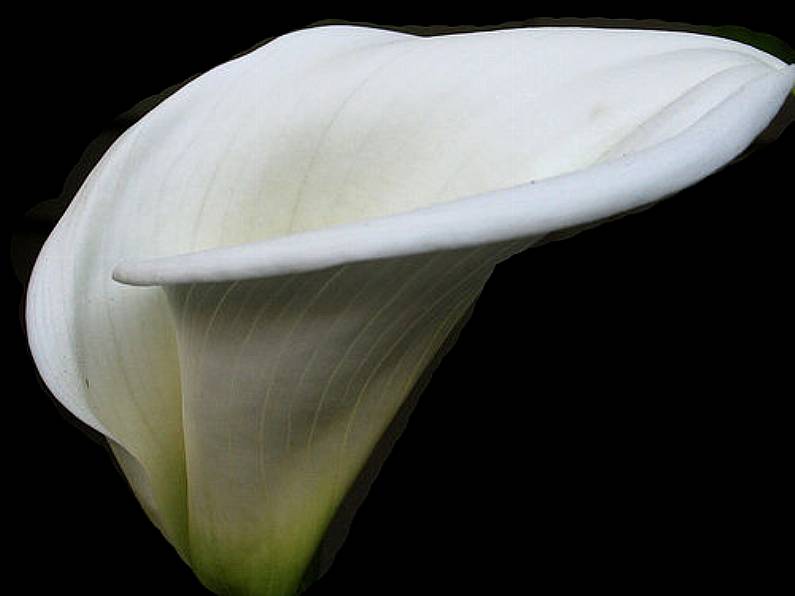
[3,10,795,596]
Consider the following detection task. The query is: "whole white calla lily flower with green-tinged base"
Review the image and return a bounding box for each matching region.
[27,26,795,595]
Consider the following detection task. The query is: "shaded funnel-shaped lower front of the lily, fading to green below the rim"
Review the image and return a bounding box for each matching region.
[168,243,519,594]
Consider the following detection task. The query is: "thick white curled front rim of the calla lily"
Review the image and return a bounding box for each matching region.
[113,65,795,286]
